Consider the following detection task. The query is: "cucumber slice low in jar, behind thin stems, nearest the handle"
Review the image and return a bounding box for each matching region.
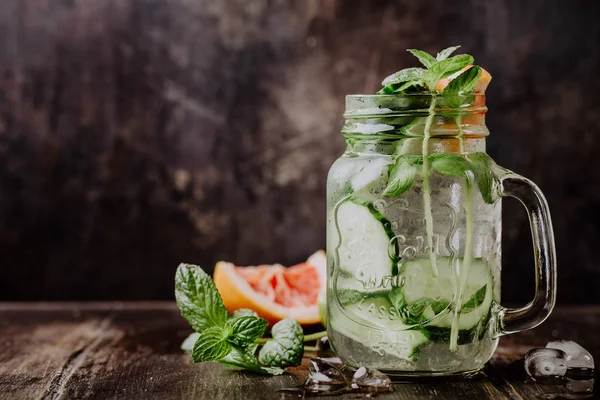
[395,257,494,330]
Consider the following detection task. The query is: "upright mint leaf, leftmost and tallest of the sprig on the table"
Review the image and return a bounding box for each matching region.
[175,264,227,332]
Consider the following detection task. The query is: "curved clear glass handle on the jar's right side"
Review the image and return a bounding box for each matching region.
[498,173,556,335]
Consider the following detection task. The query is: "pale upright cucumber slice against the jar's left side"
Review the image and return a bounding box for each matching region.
[333,200,397,291]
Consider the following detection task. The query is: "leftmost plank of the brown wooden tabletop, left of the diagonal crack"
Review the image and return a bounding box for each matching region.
[0,309,117,399]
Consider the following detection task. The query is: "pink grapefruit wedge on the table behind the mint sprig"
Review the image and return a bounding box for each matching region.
[213,250,327,325]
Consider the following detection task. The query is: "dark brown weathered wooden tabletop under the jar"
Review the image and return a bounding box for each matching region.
[0,302,600,400]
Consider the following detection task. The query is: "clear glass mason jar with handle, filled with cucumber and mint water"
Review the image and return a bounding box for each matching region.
[327,94,556,375]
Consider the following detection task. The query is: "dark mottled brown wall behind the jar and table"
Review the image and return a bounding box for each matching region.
[0,0,600,303]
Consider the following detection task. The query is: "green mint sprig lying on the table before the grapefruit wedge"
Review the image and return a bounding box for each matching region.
[175,264,304,375]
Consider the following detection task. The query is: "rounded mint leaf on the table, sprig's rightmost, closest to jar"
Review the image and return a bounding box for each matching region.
[258,318,304,367]
